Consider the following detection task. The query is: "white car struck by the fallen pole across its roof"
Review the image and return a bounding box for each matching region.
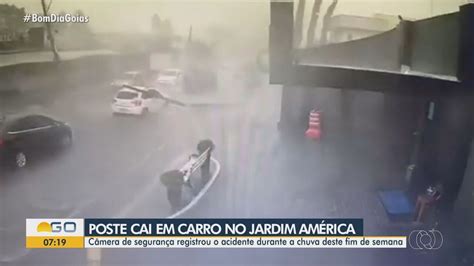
[112,85,164,115]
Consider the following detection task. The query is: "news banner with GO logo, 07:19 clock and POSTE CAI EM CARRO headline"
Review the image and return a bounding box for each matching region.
[26,219,407,248]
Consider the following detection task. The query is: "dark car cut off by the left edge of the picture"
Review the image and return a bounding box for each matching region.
[0,115,72,168]
